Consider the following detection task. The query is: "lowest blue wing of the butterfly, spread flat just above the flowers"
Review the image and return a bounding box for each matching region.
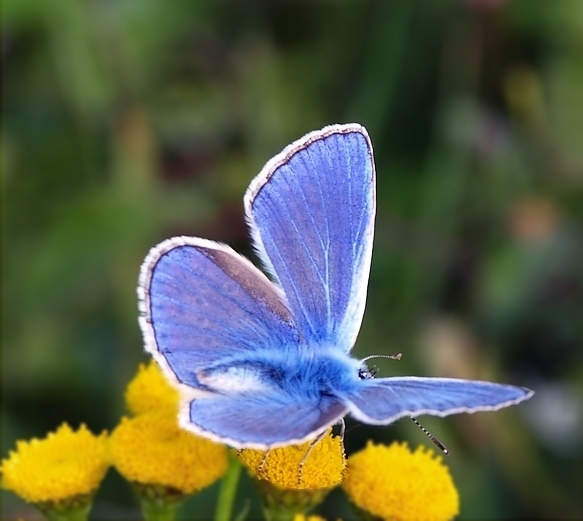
[180,392,348,450]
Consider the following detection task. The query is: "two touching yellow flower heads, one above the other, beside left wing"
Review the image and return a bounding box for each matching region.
[110,361,228,494]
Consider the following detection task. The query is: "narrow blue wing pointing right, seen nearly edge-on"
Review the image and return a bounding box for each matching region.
[346,376,534,425]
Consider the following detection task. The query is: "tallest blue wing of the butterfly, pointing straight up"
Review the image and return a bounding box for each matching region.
[245,124,375,352]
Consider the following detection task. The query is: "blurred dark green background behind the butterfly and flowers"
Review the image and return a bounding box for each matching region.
[2,0,583,519]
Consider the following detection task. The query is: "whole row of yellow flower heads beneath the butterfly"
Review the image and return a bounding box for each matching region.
[0,354,466,521]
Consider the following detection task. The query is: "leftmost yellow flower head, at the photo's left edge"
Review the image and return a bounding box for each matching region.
[1,423,109,503]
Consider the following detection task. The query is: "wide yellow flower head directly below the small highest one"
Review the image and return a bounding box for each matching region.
[110,408,227,494]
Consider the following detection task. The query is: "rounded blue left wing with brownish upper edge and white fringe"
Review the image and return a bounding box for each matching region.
[138,237,299,387]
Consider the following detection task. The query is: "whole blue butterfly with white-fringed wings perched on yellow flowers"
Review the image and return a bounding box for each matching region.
[138,124,533,449]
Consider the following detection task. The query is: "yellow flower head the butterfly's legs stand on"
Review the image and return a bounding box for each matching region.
[238,430,346,489]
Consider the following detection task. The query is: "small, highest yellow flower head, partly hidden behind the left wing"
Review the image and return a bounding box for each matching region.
[125,360,179,414]
